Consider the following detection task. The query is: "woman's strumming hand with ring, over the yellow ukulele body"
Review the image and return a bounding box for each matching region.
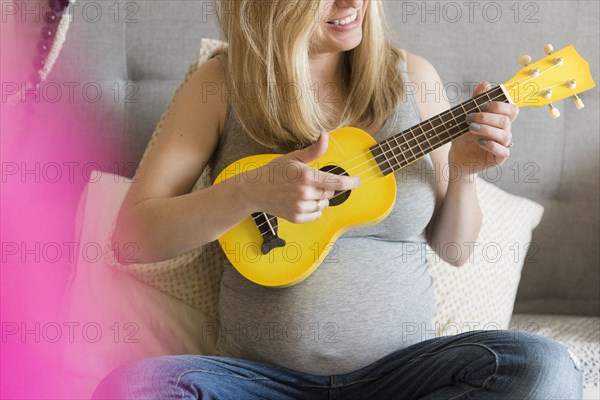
[240,133,360,223]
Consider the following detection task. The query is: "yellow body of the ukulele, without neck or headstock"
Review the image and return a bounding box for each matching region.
[214,127,396,287]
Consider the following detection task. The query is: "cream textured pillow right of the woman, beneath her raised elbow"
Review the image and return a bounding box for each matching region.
[428,178,544,335]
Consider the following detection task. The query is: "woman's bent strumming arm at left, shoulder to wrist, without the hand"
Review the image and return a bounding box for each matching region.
[112,58,254,263]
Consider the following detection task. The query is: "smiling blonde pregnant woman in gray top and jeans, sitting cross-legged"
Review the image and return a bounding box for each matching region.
[94,0,582,400]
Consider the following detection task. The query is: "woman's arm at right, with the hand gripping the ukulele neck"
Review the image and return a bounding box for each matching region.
[407,54,518,266]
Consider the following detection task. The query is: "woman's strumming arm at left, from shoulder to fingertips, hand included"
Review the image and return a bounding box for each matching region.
[112,59,358,263]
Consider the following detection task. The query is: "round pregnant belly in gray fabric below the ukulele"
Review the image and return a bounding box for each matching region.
[217,238,433,375]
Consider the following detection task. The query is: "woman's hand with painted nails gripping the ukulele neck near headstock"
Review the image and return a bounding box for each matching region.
[448,82,519,179]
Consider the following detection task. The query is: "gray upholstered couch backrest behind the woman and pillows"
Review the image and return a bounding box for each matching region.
[48,0,600,397]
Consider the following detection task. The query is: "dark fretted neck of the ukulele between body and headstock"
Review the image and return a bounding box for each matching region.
[370,85,511,175]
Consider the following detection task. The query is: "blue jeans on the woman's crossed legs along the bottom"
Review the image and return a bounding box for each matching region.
[93,330,583,400]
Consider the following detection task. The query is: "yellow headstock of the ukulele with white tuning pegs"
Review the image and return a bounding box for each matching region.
[504,44,596,118]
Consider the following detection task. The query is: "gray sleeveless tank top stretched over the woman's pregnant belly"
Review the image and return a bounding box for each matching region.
[209,55,435,375]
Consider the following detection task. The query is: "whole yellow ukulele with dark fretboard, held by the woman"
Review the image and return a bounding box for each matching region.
[214,45,595,287]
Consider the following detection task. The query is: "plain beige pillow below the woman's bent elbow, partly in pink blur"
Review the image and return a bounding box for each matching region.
[62,171,219,398]
